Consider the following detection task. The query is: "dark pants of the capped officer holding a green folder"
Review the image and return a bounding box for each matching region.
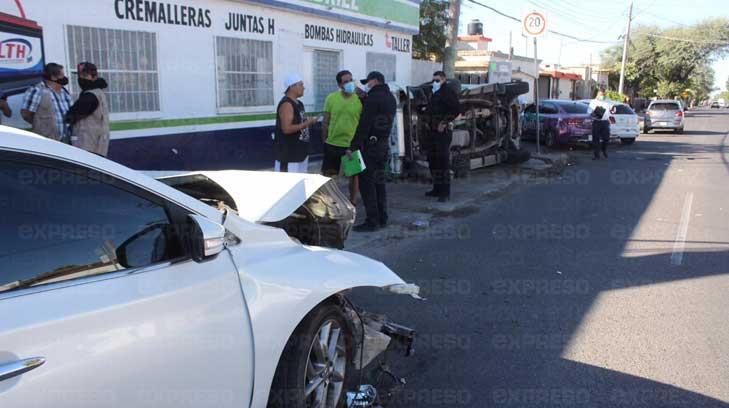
[359,143,389,225]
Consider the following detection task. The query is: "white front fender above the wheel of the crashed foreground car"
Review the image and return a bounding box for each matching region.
[226,217,413,407]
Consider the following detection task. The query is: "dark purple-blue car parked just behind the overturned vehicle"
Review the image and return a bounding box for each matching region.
[522,100,592,147]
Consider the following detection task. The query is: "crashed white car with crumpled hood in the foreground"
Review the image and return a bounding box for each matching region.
[0,127,418,408]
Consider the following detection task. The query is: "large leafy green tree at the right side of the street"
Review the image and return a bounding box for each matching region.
[602,18,729,99]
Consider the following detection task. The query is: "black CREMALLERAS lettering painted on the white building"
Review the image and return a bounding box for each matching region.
[114,0,213,28]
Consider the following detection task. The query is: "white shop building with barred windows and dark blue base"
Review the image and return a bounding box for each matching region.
[0,0,420,170]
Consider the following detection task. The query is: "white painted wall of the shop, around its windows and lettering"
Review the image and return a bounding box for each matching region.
[5,0,411,137]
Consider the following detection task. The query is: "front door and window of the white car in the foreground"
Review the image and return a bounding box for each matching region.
[0,150,253,408]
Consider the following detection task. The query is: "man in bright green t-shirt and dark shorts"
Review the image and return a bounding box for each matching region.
[321,71,362,204]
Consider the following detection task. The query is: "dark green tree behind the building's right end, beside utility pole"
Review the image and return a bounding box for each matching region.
[413,0,448,61]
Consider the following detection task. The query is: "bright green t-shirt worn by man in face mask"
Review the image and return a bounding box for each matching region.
[324,91,362,147]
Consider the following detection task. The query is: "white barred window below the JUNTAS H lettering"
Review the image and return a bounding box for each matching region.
[215,37,273,108]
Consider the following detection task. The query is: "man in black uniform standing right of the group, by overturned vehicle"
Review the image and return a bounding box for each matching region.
[425,71,461,202]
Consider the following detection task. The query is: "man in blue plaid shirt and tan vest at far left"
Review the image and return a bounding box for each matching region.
[20,63,72,143]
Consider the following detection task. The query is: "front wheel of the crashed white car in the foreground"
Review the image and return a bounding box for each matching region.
[268,303,354,408]
